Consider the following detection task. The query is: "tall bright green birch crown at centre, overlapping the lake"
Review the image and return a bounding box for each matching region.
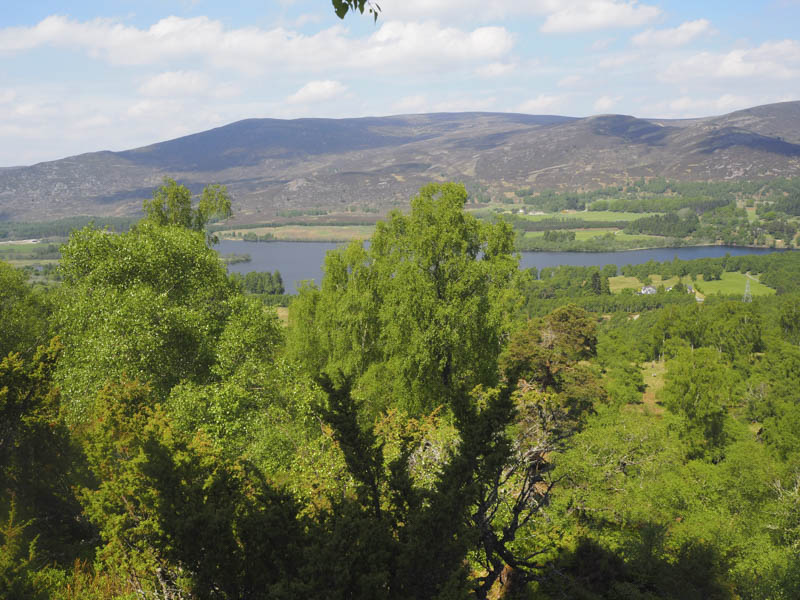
[289,184,518,414]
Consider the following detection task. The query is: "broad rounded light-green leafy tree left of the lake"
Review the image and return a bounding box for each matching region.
[55,223,236,419]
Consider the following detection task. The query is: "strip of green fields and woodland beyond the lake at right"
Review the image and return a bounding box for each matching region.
[500,178,800,252]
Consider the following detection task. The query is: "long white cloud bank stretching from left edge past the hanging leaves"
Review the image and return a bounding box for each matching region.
[0,16,514,75]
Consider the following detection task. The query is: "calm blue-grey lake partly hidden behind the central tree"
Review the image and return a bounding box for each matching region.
[216,240,780,294]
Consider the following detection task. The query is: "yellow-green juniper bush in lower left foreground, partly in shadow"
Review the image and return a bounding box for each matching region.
[82,381,302,598]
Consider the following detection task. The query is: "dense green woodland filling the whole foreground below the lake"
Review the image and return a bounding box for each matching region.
[0,182,800,600]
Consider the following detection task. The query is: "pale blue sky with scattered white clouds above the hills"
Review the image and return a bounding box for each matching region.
[0,0,800,167]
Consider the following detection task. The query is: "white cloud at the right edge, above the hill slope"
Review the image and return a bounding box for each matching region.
[662,40,800,82]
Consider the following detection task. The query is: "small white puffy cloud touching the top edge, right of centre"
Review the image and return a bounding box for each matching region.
[540,0,661,33]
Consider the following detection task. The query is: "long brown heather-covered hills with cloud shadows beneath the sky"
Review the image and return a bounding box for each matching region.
[0,102,800,220]
